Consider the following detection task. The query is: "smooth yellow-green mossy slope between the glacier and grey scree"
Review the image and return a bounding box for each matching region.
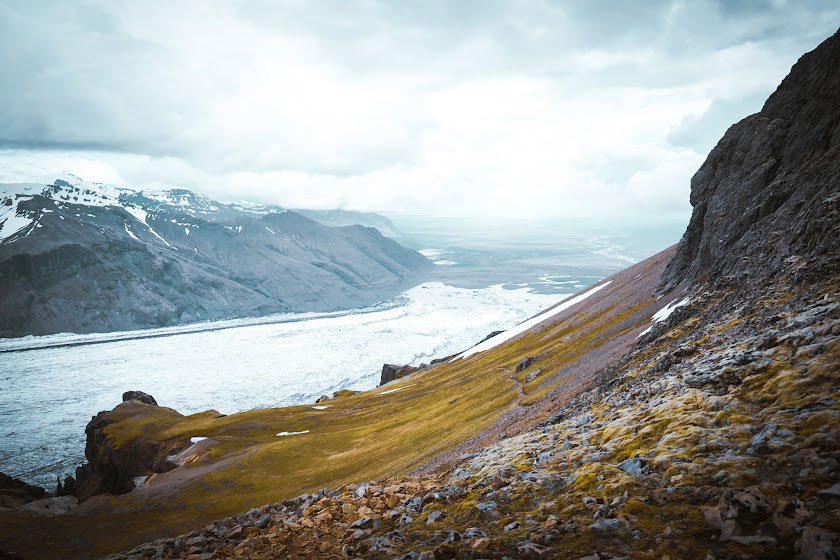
[0,250,672,558]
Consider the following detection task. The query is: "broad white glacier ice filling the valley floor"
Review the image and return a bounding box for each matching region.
[0,282,563,486]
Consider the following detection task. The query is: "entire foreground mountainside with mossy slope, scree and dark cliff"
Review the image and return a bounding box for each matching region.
[0,28,840,560]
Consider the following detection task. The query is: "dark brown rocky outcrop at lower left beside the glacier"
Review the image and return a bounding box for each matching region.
[56,391,190,501]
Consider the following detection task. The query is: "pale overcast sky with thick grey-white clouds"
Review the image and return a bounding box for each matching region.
[0,0,840,219]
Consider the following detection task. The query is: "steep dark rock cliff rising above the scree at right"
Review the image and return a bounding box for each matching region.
[663,32,840,294]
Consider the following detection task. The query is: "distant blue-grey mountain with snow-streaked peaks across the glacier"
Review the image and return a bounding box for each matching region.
[0,177,431,336]
